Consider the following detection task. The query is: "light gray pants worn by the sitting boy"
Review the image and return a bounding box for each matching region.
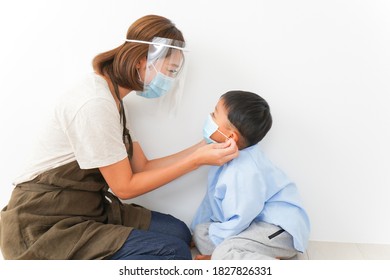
[193,222,298,260]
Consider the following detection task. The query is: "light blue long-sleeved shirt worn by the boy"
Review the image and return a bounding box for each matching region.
[191,144,310,252]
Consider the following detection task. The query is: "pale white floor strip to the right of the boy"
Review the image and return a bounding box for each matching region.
[0,241,390,260]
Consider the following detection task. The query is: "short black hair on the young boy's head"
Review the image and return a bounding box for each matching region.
[221,90,272,148]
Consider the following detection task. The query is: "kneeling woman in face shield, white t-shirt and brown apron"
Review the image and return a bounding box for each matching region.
[0,15,238,259]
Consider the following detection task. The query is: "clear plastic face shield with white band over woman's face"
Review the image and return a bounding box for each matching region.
[126,37,186,115]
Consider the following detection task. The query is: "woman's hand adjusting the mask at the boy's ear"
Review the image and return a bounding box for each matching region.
[195,139,238,166]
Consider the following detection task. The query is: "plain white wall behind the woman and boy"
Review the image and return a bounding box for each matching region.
[0,0,390,244]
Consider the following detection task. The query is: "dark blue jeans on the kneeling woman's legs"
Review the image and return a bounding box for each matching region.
[111,211,192,260]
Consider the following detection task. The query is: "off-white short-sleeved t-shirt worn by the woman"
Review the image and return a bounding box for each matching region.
[14,73,136,185]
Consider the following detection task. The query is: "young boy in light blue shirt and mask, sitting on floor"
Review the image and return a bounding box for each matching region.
[191,91,310,259]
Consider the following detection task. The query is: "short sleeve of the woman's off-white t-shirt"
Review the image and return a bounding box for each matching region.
[65,98,127,169]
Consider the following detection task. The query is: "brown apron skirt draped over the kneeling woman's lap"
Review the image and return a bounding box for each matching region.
[0,161,151,260]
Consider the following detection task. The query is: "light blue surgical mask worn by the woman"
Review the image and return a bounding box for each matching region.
[137,64,175,98]
